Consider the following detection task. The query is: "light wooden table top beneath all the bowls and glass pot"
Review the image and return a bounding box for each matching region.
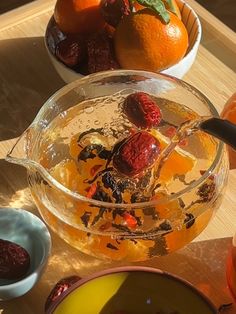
[0,0,236,314]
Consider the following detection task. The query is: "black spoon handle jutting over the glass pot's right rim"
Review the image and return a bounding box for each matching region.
[200,118,236,149]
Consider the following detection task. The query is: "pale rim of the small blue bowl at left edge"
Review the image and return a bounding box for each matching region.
[0,207,52,293]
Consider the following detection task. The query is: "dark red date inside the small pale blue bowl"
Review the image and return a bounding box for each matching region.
[0,239,30,279]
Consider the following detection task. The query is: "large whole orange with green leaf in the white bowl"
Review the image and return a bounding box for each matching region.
[114,9,188,71]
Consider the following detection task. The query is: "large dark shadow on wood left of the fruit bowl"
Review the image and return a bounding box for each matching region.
[0,37,64,141]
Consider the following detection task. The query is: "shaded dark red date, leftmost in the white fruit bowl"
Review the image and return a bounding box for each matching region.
[55,37,86,67]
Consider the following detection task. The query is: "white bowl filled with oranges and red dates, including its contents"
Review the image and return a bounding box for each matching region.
[45,0,202,83]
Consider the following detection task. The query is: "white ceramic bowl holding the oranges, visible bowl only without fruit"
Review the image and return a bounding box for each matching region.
[44,0,202,83]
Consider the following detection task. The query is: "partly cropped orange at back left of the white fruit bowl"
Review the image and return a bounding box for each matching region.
[54,0,105,34]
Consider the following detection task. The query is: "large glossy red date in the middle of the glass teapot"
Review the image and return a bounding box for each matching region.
[113,131,160,177]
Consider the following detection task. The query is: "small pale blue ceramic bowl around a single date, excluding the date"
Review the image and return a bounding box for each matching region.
[0,208,51,301]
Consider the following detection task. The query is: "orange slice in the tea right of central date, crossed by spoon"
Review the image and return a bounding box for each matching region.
[152,130,196,182]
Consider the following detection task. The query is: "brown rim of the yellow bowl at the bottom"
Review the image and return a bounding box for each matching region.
[46,266,218,314]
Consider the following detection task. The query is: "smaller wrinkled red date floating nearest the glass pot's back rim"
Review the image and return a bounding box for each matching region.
[123,92,162,129]
